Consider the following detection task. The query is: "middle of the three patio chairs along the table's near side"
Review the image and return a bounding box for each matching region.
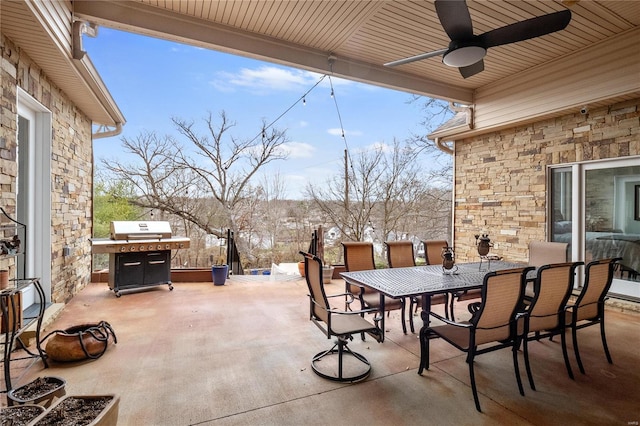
[522,262,584,390]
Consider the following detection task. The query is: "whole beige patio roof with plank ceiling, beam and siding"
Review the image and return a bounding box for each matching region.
[73,0,640,140]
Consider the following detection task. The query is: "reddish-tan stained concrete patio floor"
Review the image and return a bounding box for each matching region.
[3,277,640,425]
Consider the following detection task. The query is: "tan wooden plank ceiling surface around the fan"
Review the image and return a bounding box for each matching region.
[112,0,640,99]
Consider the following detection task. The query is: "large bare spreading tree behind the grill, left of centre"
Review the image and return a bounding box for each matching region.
[101,111,287,236]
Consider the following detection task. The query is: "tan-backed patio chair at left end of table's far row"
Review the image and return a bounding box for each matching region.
[342,241,407,336]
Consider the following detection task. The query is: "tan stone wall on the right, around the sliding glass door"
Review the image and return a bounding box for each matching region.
[454,99,640,261]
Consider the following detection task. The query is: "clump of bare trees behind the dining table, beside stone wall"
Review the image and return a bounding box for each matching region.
[307,141,451,256]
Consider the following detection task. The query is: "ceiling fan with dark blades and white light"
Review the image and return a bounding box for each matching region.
[384,0,571,78]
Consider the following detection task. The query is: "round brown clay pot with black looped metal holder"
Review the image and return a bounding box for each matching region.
[45,321,118,362]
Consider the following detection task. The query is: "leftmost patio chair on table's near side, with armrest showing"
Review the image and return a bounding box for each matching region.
[420,268,533,411]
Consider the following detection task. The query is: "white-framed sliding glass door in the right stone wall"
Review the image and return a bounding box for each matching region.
[549,158,640,299]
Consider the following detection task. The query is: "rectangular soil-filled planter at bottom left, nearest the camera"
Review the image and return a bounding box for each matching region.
[29,395,120,426]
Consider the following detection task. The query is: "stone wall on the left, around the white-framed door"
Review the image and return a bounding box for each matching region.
[0,34,93,303]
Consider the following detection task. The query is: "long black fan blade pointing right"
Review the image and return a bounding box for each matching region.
[478,10,571,49]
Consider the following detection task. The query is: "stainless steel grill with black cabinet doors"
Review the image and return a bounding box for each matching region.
[91,221,190,297]
